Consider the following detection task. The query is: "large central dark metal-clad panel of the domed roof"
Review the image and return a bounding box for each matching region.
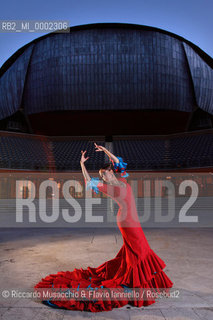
[21,28,194,113]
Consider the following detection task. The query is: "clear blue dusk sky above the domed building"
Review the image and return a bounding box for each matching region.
[0,0,213,66]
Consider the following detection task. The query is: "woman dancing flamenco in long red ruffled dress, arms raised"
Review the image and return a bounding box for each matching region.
[34,143,173,312]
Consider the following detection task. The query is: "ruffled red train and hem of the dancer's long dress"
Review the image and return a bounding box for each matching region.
[34,247,173,312]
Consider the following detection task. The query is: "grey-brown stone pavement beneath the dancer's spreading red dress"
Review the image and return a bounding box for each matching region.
[0,228,213,320]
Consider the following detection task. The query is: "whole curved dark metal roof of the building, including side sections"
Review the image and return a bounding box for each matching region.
[0,23,213,119]
